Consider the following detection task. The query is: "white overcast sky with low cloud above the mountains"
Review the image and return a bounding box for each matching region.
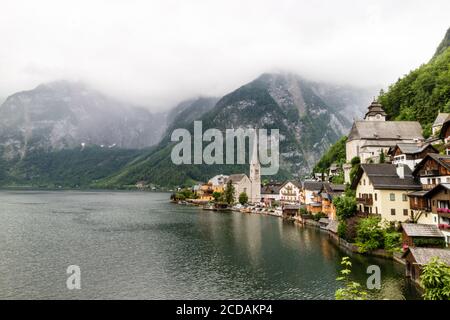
[0,0,450,109]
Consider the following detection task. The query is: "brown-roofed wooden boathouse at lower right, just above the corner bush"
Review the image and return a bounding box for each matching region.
[402,247,450,284]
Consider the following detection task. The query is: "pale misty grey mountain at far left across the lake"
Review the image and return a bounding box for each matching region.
[0,81,166,160]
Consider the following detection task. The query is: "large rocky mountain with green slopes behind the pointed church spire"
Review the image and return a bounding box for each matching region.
[97,74,370,187]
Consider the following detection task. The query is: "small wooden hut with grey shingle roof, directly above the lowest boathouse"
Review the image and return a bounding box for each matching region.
[400,223,445,248]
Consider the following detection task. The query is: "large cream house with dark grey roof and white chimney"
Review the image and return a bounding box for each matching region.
[351,163,422,222]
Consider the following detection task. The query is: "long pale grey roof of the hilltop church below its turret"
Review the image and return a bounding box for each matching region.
[348,120,423,141]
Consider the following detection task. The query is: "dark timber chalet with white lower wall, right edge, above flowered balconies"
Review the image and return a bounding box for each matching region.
[413,153,450,190]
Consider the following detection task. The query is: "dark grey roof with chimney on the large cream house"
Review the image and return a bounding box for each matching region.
[352,163,422,190]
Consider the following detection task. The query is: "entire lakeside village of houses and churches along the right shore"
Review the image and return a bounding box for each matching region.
[172,101,450,282]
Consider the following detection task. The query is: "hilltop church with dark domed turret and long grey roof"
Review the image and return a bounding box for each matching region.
[346,101,424,170]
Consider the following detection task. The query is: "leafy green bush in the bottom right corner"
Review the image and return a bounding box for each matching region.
[420,257,450,300]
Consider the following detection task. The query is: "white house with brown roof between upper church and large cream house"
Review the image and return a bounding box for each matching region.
[388,143,439,170]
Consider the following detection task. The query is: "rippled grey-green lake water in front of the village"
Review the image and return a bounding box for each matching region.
[0,191,417,299]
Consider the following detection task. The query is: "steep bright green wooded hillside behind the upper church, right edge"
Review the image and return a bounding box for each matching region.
[379,29,450,134]
